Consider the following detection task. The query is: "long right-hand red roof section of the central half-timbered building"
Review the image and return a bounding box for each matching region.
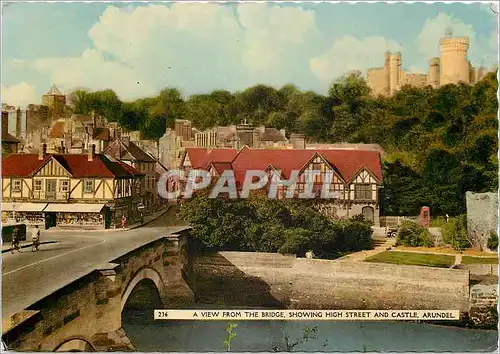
[231,147,382,183]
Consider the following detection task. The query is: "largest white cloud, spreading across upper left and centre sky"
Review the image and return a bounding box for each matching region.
[26,3,317,99]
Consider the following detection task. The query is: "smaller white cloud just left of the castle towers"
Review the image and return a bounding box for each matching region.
[309,36,404,83]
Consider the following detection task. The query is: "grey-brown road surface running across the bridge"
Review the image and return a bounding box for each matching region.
[2,212,186,319]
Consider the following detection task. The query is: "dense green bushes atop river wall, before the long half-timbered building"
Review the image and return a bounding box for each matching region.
[179,194,373,258]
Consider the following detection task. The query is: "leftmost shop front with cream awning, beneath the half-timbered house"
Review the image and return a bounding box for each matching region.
[2,202,47,227]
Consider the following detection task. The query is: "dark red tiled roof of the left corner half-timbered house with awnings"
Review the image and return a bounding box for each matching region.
[2,154,143,178]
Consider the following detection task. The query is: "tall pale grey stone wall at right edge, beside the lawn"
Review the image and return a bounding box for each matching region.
[466,192,498,249]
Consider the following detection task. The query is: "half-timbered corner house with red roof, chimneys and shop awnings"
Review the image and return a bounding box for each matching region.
[2,144,144,229]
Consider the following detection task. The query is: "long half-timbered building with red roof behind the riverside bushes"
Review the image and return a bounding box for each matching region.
[182,147,382,225]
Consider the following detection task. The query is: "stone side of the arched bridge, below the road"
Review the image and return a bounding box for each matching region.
[2,229,194,352]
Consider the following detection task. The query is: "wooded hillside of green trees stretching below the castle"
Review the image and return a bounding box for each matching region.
[70,72,498,216]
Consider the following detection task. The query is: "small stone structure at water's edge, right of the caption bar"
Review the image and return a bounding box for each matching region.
[469,283,498,328]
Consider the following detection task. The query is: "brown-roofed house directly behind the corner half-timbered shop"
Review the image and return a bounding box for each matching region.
[105,136,158,214]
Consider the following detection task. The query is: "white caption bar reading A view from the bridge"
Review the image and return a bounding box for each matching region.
[154,310,460,321]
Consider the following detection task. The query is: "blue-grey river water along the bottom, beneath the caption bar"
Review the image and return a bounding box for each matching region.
[122,310,498,352]
